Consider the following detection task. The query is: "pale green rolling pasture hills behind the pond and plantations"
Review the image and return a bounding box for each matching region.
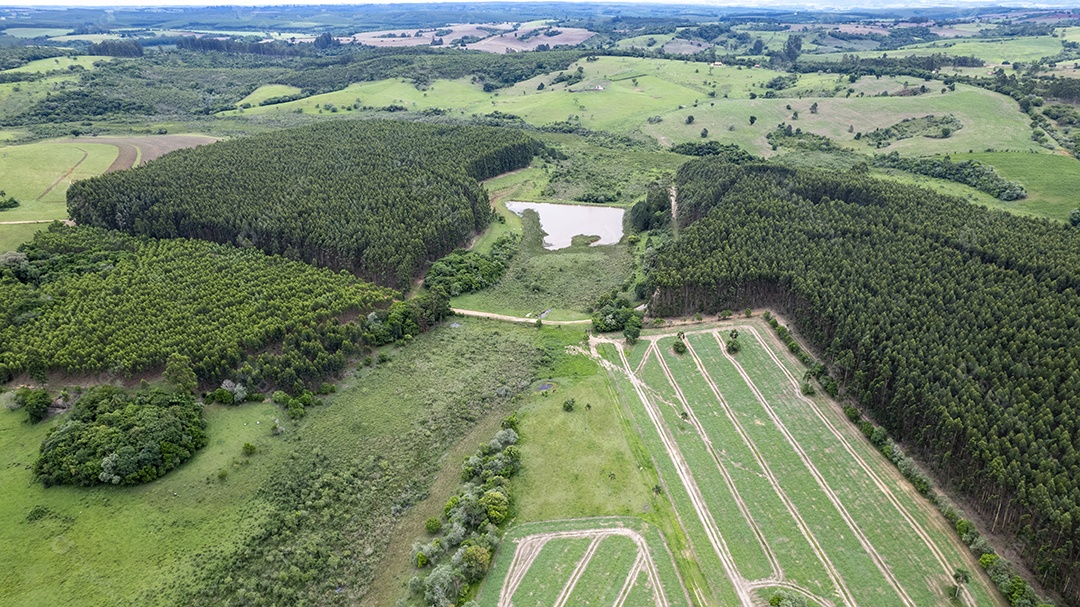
[227,55,1045,154]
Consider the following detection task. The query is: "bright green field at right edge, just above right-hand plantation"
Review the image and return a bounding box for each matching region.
[954,152,1080,221]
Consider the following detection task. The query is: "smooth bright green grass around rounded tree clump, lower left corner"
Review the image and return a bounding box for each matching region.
[0,397,284,607]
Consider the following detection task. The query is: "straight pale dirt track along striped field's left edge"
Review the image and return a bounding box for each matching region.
[590,337,754,607]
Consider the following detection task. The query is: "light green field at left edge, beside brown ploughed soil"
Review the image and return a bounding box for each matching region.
[0,143,118,221]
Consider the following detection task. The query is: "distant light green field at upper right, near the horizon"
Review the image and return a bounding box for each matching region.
[813,36,1062,64]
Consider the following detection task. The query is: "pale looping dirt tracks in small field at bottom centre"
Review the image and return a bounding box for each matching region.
[498,528,670,607]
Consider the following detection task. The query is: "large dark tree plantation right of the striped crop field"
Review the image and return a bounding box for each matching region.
[649,159,1080,601]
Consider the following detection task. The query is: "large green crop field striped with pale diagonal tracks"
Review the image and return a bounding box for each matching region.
[592,320,999,607]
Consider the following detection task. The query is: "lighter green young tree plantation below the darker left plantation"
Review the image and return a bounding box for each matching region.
[0,225,397,391]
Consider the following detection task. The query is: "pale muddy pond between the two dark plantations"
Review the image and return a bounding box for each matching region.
[507,200,624,251]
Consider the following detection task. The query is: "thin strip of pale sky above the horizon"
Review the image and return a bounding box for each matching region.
[8,0,1080,12]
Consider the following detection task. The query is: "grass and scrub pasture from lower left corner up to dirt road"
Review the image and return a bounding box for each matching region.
[0,319,569,606]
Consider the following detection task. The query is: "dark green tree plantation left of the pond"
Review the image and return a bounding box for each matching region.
[68,121,541,287]
